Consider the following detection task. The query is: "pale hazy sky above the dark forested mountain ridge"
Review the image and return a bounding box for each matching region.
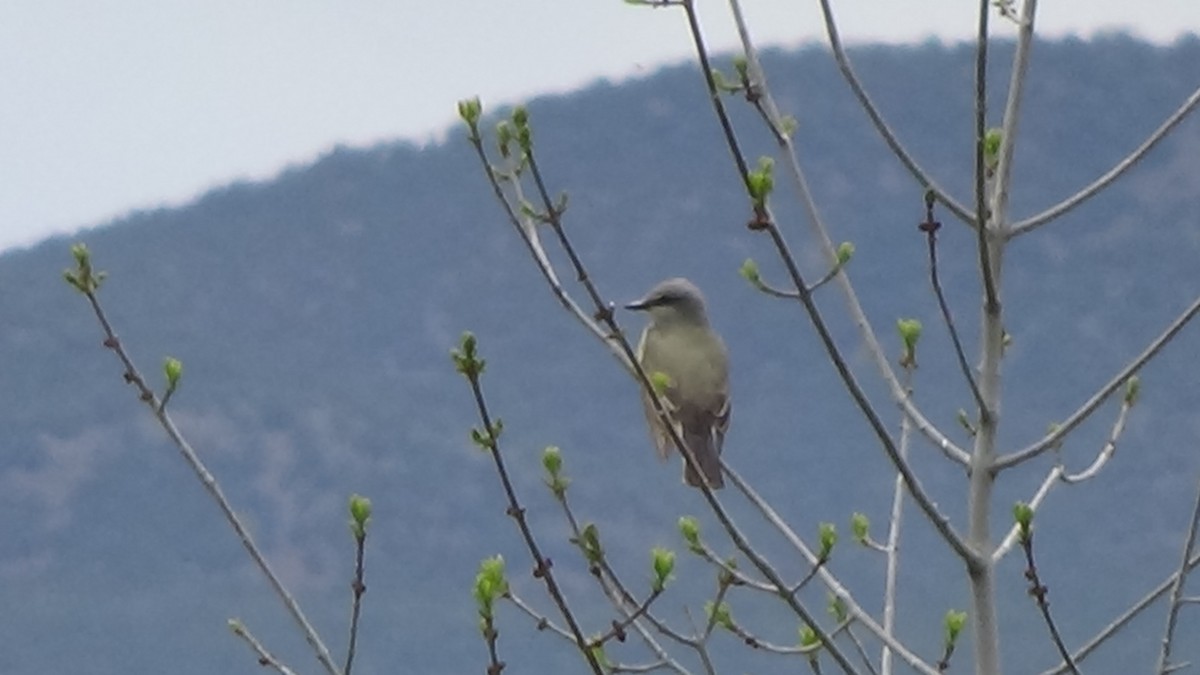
[0,0,1200,250]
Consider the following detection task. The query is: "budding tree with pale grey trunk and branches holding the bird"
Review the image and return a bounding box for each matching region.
[455,0,1200,674]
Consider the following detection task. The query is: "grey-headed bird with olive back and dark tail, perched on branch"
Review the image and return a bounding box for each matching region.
[625,279,730,489]
